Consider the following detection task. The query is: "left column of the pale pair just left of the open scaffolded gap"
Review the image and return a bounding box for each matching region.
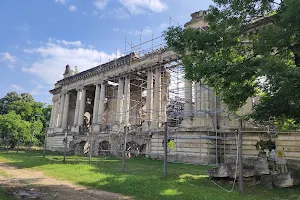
[143,70,153,131]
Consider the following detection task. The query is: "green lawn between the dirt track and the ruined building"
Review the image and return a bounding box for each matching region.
[0,152,300,200]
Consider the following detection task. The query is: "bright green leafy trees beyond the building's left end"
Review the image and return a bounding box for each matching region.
[0,92,52,147]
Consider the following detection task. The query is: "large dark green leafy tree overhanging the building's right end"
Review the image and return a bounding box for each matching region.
[165,0,300,124]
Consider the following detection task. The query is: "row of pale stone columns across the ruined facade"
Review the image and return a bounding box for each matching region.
[50,67,215,132]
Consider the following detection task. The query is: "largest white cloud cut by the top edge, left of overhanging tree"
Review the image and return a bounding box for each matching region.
[120,0,168,14]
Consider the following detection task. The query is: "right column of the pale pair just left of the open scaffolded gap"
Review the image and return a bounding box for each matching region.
[151,67,161,128]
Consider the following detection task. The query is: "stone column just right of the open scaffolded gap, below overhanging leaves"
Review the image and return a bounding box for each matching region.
[184,80,193,117]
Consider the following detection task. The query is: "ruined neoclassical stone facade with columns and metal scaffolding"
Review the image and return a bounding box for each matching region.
[47,11,252,164]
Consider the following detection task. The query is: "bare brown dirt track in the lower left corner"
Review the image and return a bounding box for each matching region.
[0,163,132,200]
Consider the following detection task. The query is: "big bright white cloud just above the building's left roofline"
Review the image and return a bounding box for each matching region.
[22,40,120,85]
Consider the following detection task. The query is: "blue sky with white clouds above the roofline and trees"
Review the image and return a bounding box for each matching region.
[0,0,211,103]
